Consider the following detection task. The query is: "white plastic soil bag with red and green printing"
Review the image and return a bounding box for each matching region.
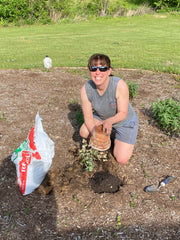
[11,113,54,195]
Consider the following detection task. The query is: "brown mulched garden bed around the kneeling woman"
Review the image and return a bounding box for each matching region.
[0,68,180,240]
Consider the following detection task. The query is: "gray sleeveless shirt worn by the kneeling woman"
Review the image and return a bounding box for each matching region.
[85,76,134,128]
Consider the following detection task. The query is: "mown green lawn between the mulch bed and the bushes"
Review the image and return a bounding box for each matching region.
[0,14,180,73]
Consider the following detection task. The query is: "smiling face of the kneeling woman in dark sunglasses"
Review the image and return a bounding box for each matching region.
[91,61,112,87]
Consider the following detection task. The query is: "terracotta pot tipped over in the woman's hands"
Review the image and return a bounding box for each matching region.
[89,124,111,151]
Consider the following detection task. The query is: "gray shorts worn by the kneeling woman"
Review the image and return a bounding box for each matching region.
[113,113,138,145]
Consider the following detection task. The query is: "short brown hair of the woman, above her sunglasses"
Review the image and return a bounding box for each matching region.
[88,53,111,70]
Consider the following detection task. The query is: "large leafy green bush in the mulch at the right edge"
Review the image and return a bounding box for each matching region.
[152,98,180,136]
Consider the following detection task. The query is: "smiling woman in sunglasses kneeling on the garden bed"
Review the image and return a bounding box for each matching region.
[80,53,138,164]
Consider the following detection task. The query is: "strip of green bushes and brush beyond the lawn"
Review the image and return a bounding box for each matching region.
[0,0,180,24]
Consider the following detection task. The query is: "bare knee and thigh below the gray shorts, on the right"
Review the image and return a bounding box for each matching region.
[113,139,134,164]
